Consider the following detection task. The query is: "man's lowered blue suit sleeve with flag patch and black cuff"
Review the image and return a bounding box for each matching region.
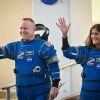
[40,42,60,87]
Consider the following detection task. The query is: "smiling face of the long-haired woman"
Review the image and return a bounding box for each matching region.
[91,28,100,46]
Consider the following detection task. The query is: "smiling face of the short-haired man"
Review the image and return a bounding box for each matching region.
[20,20,36,40]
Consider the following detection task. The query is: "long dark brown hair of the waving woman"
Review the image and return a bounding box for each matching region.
[85,24,100,48]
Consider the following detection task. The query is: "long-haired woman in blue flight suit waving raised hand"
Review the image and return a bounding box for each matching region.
[57,18,100,100]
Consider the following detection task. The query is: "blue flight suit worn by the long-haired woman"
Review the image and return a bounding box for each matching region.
[63,46,100,100]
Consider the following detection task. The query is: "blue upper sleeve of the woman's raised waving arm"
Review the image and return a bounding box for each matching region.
[62,46,88,64]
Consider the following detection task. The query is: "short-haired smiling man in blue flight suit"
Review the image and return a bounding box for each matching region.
[0,18,60,100]
